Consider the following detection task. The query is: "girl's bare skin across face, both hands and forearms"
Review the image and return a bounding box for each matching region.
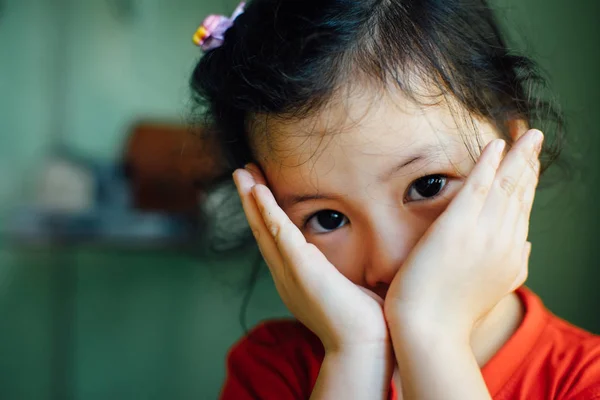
[234,83,542,399]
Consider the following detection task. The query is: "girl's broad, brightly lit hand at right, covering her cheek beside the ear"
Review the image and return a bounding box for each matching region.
[385,130,543,340]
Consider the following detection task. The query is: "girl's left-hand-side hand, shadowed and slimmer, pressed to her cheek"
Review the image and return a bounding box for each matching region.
[234,165,391,352]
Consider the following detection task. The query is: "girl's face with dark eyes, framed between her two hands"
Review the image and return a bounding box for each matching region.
[255,87,506,298]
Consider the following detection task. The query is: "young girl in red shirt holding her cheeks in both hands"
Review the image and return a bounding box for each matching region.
[192,0,600,400]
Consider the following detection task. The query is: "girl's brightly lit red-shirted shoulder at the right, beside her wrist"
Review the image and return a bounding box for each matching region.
[482,288,600,400]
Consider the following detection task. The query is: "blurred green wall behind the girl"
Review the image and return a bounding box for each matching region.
[0,0,600,400]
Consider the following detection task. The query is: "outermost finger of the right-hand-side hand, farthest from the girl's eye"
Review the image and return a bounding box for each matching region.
[482,129,543,225]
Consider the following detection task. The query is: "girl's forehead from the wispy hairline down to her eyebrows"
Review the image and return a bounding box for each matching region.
[253,87,488,189]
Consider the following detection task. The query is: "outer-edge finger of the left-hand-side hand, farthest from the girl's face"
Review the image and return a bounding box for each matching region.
[233,169,282,279]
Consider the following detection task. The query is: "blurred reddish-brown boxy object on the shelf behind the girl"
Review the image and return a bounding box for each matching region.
[124,123,223,214]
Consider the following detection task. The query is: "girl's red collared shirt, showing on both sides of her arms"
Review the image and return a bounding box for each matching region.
[221,288,600,400]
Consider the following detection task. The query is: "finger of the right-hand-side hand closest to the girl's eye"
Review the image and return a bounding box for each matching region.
[445,139,506,216]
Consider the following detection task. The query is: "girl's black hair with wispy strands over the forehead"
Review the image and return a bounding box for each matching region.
[191,0,565,328]
